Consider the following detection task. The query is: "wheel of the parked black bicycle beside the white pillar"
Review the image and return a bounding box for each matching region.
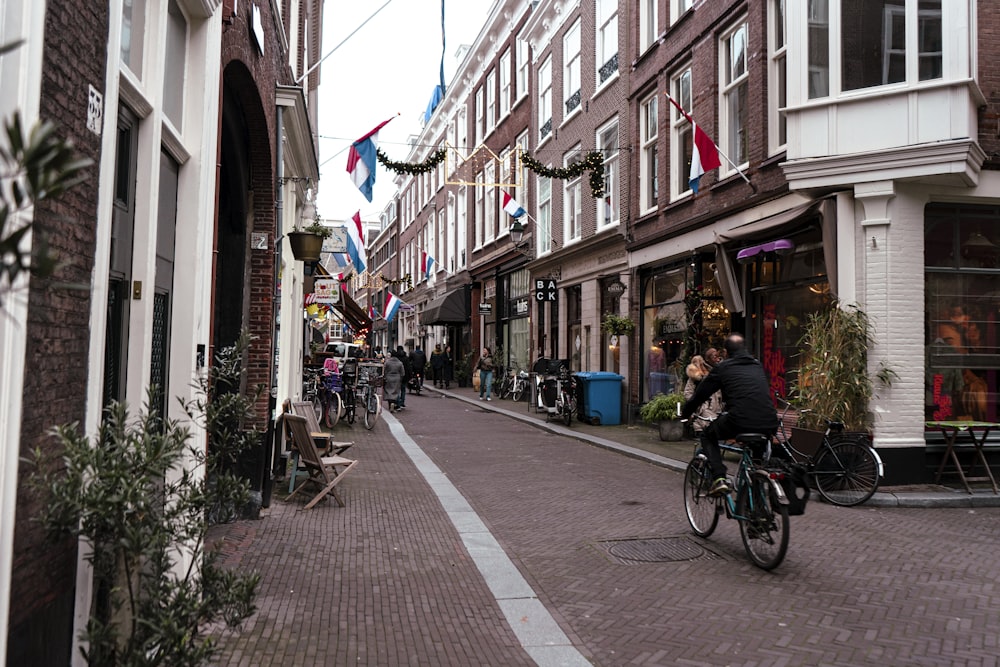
[811,439,879,507]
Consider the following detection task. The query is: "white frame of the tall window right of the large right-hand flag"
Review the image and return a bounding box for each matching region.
[718,16,750,174]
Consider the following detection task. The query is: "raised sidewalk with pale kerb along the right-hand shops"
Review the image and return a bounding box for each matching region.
[436,385,1000,507]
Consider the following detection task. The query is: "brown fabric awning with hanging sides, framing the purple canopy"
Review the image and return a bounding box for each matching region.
[715,197,837,313]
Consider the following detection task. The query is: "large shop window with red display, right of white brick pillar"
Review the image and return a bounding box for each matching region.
[924,204,1000,422]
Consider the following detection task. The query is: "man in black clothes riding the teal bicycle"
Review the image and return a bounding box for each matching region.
[681,333,778,496]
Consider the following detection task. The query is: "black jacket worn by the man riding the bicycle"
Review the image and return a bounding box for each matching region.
[681,351,778,431]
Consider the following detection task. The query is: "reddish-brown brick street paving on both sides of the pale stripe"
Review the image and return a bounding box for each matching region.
[207,390,1000,666]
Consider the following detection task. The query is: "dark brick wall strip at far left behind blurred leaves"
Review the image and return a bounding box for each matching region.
[7,0,108,665]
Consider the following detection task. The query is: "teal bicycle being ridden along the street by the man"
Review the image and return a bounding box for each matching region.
[684,426,790,570]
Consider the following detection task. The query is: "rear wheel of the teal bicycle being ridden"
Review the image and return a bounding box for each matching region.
[736,475,789,570]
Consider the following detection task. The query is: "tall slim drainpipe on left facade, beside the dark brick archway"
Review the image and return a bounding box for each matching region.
[260,105,287,507]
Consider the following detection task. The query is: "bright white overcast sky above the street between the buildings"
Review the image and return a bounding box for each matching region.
[316,0,495,220]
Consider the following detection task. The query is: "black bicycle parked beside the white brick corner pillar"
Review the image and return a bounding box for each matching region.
[775,394,884,507]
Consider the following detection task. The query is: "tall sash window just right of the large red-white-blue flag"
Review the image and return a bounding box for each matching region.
[719,23,750,167]
